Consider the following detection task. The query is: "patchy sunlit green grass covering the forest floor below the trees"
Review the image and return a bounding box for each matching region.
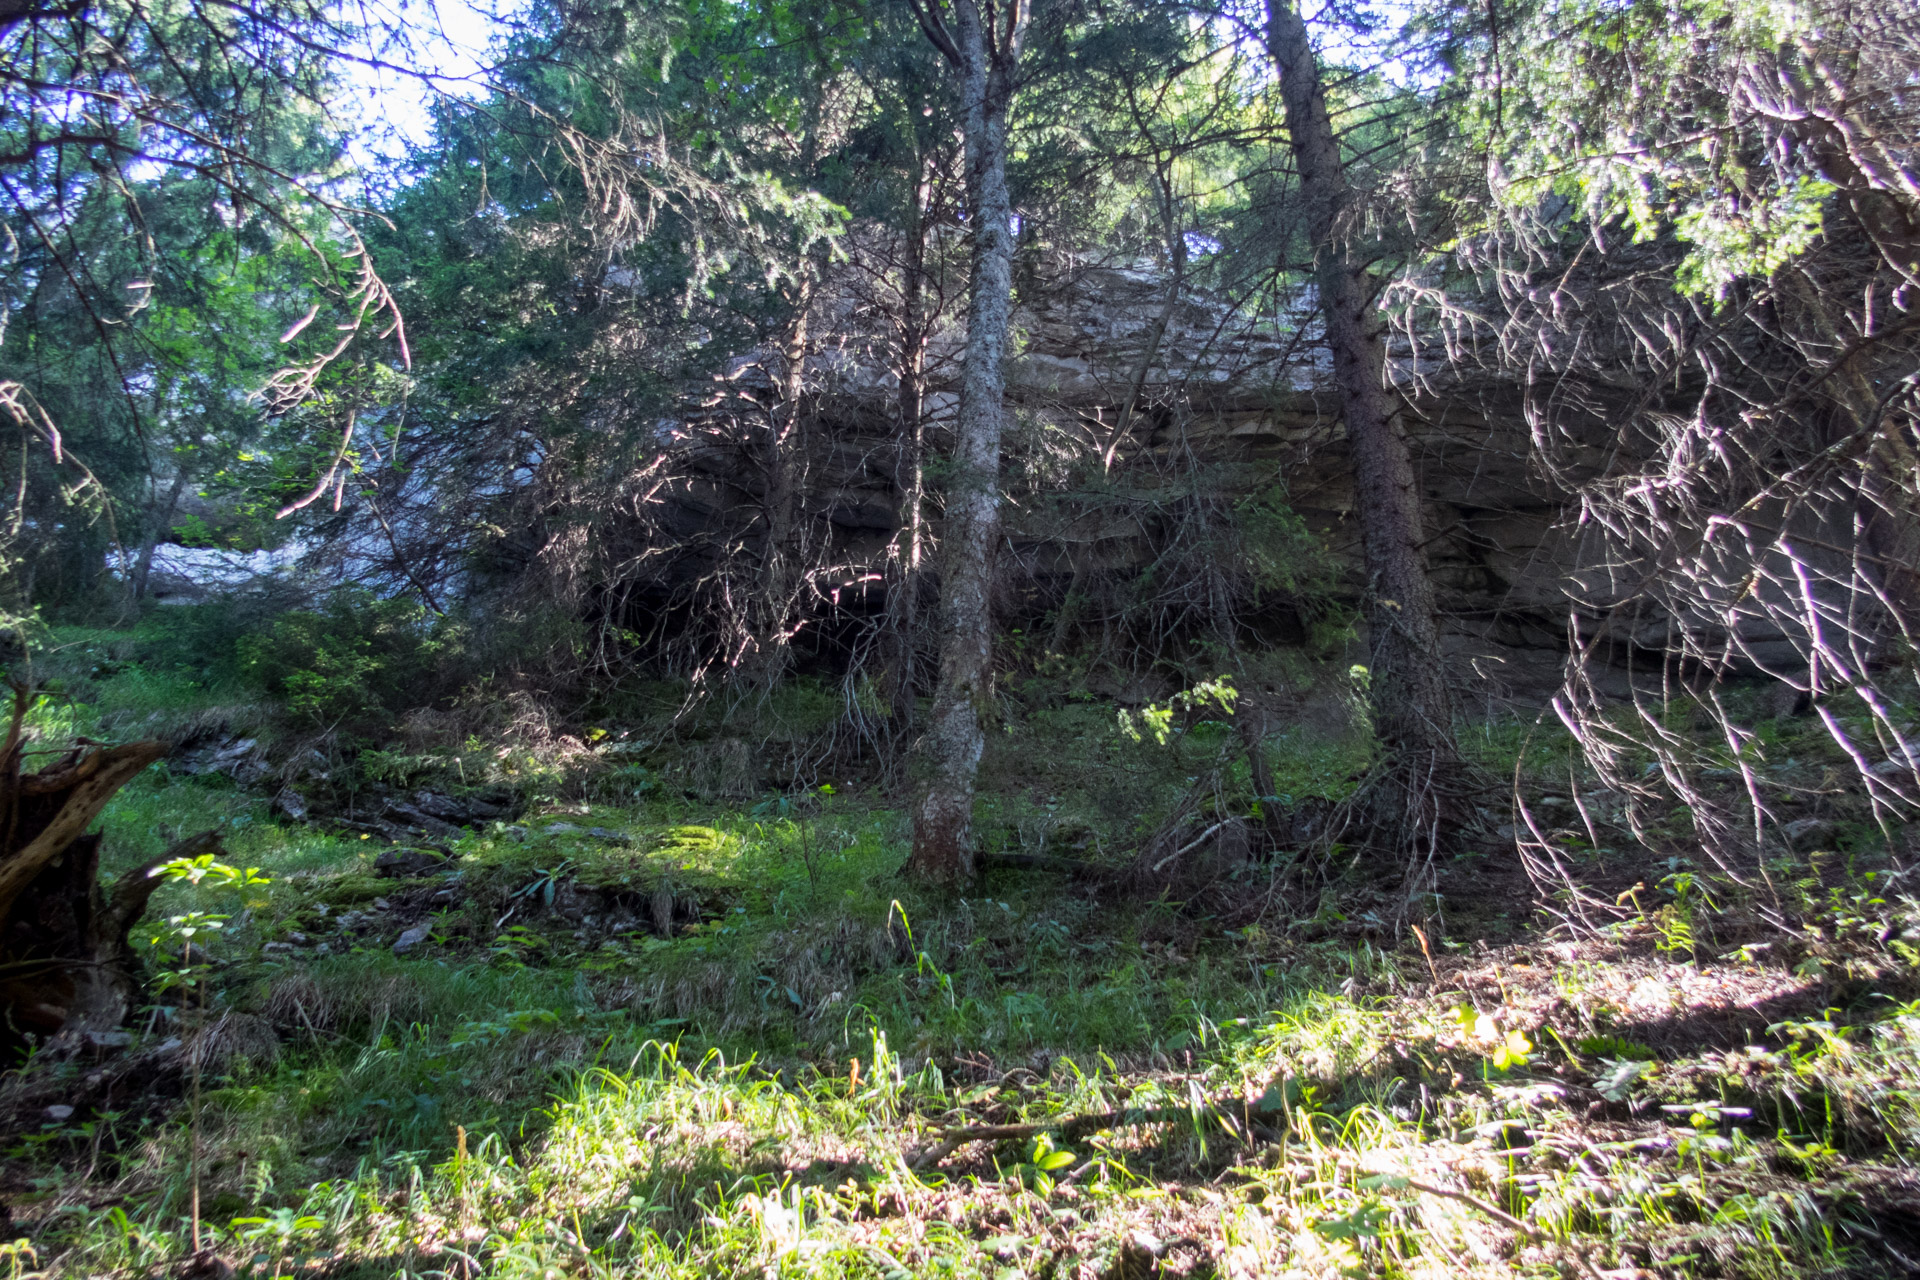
[0,641,1920,1280]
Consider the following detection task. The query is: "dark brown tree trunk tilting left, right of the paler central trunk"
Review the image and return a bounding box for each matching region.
[1267,0,1459,841]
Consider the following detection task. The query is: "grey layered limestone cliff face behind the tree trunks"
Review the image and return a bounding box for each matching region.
[674,249,1791,699]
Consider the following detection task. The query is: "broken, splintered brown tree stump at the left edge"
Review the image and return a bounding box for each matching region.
[0,689,192,1048]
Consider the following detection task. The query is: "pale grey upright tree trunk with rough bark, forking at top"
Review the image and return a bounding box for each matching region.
[906,0,1027,881]
